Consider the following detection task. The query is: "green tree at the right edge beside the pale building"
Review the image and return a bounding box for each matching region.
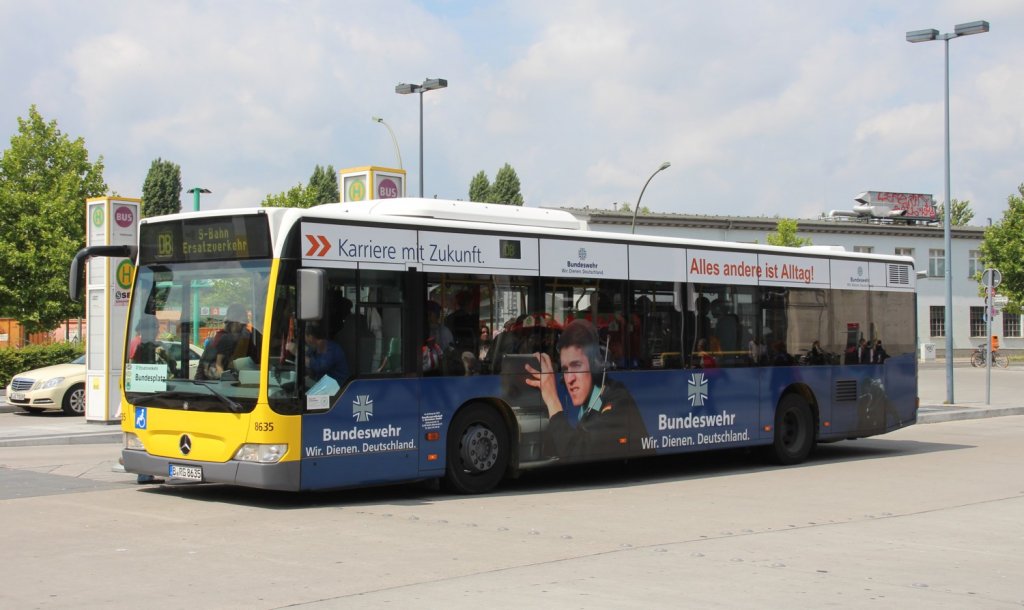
[978,184,1024,312]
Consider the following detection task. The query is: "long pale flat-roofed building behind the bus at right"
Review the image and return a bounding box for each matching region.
[565,208,1024,357]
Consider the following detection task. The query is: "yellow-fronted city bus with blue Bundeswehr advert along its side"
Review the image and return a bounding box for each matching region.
[72,199,919,493]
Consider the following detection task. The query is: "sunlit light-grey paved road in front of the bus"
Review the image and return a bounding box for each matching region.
[0,416,1024,610]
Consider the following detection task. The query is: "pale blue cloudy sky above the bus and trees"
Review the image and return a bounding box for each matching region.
[0,0,1024,224]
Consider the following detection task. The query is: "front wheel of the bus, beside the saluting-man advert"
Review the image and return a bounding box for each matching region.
[444,404,511,493]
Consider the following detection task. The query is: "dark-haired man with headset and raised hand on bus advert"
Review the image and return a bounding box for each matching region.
[525,319,647,458]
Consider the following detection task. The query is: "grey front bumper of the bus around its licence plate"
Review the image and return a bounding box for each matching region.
[121,449,300,491]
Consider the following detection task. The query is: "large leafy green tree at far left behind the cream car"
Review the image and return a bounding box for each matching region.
[0,104,106,333]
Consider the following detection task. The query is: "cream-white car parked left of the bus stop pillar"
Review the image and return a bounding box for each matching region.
[7,355,85,416]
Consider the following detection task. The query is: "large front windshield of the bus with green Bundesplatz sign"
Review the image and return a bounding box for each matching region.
[124,259,270,412]
